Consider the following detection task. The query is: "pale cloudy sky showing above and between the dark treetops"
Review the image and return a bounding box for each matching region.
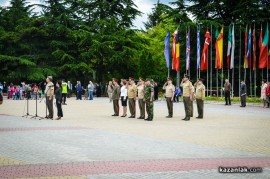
[0,0,174,28]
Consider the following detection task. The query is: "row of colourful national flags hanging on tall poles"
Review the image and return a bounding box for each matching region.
[164,24,270,71]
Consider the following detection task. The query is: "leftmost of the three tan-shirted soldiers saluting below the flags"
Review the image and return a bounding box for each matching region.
[163,78,175,118]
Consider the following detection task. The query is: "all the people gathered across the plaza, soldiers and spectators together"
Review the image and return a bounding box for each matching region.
[0,75,270,121]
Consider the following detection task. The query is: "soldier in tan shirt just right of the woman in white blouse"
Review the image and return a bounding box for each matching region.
[128,77,137,118]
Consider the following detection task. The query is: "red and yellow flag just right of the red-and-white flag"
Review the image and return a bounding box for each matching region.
[215,27,223,69]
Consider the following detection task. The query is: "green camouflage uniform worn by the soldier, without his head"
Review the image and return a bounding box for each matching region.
[144,84,154,121]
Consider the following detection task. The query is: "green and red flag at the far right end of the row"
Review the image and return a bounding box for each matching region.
[259,24,269,68]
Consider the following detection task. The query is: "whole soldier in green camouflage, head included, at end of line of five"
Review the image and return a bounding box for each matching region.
[144,78,154,121]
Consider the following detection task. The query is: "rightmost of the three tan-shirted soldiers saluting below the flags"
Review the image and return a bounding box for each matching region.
[194,78,205,119]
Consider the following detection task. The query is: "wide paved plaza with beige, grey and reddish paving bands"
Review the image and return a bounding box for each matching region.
[0,98,270,179]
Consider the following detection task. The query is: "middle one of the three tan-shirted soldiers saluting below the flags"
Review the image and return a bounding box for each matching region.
[181,75,193,121]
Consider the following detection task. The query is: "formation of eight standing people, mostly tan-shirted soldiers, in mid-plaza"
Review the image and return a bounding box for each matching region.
[110,75,205,121]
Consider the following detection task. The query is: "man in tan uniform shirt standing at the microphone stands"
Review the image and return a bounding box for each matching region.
[45,76,54,119]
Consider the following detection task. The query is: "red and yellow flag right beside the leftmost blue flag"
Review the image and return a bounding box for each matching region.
[172,28,180,71]
